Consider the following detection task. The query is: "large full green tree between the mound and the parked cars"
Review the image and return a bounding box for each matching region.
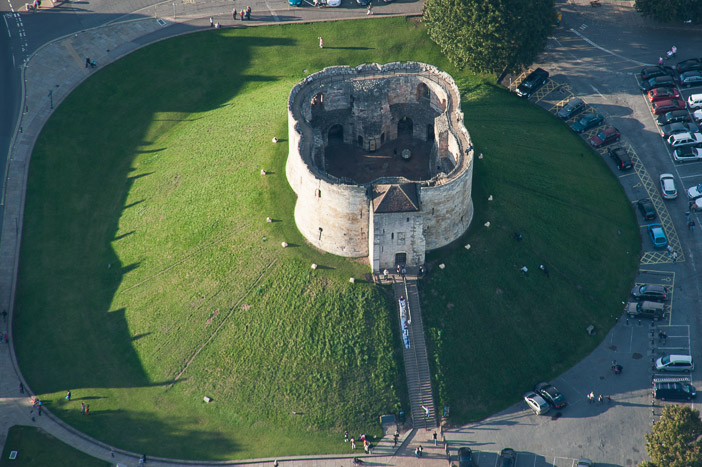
[423,0,556,73]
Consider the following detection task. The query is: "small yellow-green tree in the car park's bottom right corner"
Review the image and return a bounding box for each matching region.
[645,405,702,467]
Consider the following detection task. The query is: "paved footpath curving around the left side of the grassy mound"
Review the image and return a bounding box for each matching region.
[0,1,446,466]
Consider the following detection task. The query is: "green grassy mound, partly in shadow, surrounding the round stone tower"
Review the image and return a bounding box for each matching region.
[14,18,637,459]
